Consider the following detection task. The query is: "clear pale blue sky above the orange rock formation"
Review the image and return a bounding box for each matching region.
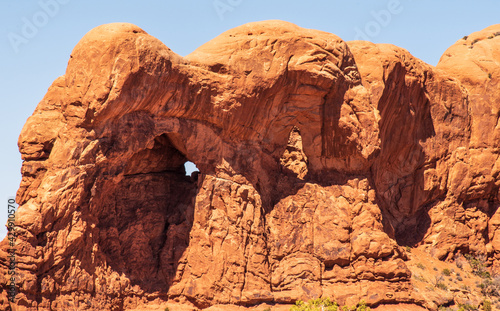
[0,0,500,238]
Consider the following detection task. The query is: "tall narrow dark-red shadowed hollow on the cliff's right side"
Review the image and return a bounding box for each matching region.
[371,63,443,246]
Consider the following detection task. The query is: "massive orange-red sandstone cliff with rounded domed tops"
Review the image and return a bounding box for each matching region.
[0,21,500,310]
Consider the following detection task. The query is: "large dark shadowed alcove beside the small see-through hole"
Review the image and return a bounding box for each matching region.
[95,134,198,296]
